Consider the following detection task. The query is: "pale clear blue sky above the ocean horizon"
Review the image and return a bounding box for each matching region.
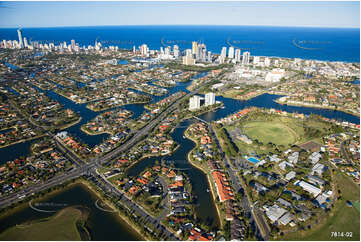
[0,2,360,28]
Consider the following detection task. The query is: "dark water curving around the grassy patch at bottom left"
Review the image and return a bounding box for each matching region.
[0,184,142,241]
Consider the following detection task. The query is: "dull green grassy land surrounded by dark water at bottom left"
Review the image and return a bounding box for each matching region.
[0,207,82,241]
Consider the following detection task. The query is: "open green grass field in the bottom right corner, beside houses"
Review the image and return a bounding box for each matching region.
[278,173,360,241]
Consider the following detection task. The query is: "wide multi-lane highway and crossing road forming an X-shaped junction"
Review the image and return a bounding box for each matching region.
[0,79,208,240]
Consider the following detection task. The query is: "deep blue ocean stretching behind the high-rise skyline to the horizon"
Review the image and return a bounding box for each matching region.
[0,26,360,62]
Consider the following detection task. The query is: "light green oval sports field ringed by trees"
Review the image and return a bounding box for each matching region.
[243,121,298,145]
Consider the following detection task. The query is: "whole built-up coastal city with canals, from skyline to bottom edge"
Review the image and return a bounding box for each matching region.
[0,27,360,240]
